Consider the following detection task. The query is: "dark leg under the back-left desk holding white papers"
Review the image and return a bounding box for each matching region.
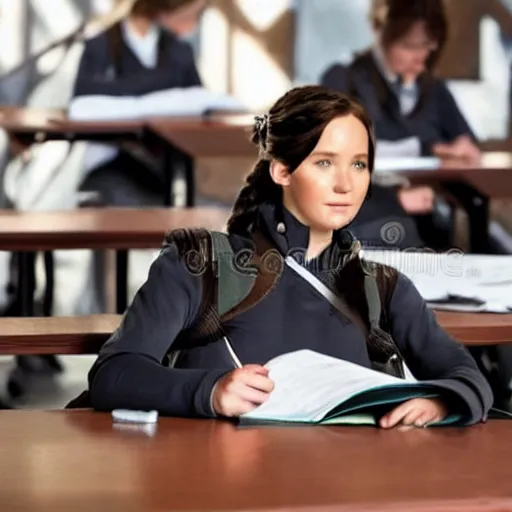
[164,147,196,207]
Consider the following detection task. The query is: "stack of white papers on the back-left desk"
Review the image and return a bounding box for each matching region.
[68,87,247,121]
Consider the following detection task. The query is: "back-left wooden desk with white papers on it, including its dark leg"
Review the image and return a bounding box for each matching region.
[0,108,258,206]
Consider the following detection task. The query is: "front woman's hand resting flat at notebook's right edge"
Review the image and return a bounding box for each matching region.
[380,398,448,428]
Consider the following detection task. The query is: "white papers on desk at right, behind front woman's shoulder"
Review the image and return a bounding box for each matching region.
[363,250,512,313]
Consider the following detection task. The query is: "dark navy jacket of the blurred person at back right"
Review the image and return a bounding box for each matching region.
[321,51,474,155]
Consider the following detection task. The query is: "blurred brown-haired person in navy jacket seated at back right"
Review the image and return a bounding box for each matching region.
[321,0,480,249]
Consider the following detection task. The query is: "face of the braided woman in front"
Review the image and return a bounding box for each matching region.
[271,115,370,232]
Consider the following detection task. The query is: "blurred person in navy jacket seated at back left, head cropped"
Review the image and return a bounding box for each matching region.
[74,0,206,206]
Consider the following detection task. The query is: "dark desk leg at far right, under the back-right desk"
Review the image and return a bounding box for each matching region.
[445,183,491,254]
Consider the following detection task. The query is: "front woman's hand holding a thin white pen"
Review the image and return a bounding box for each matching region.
[212,364,274,417]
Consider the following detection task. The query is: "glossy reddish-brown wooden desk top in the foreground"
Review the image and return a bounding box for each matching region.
[0,411,512,512]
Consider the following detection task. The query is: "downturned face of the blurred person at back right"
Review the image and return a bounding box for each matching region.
[385,21,436,80]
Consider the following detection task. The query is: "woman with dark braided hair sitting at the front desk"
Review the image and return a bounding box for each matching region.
[83,86,492,427]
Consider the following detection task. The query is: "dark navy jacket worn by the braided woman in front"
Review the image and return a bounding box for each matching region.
[89,205,492,422]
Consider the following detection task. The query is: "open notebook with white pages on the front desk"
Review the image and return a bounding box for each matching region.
[240,350,464,425]
